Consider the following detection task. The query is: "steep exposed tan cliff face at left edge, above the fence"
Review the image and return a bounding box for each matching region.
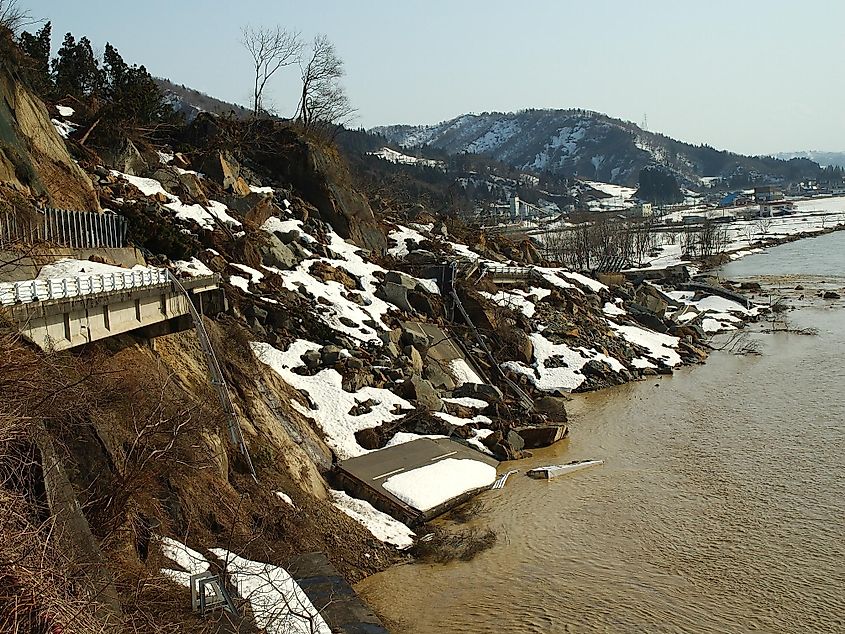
[0,61,100,211]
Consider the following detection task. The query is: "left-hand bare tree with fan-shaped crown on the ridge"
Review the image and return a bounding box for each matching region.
[241,25,302,117]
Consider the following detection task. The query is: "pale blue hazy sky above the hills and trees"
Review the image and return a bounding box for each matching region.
[29,0,845,154]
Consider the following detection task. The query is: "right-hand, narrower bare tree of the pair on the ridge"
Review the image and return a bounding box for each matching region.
[297,35,355,128]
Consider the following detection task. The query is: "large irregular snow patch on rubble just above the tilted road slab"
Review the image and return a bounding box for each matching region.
[251,339,414,460]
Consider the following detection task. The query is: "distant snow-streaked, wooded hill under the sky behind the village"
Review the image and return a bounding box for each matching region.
[373,110,820,186]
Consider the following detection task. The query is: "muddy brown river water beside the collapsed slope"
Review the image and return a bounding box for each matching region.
[358,232,845,634]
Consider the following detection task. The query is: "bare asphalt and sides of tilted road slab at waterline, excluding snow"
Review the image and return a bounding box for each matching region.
[337,438,499,526]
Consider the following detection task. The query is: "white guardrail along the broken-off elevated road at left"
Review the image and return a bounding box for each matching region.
[0,268,170,306]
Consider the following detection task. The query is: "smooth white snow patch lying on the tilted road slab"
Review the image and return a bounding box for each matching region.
[383,458,496,512]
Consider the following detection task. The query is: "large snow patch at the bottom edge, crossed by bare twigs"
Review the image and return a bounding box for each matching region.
[211,548,331,634]
